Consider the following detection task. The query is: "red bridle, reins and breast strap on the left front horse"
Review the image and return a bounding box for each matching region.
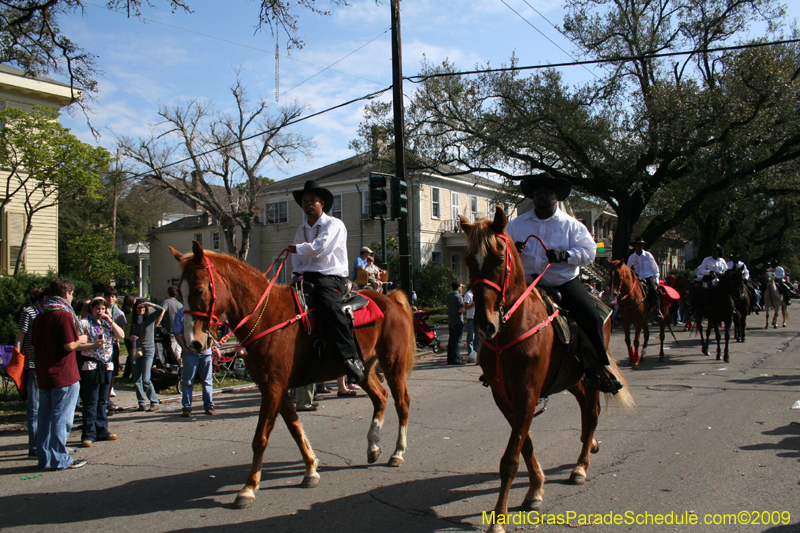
[183,248,314,355]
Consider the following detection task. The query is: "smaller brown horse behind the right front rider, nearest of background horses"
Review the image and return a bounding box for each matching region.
[608,260,674,368]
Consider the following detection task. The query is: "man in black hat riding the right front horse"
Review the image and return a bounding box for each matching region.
[506,172,622,394]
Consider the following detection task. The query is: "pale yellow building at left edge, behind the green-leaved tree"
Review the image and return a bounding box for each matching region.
[0,65,73,274]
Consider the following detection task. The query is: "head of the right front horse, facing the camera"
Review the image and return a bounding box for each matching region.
[459,206,525,340]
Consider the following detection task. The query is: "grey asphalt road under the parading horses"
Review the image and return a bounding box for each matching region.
[0,318,800,533]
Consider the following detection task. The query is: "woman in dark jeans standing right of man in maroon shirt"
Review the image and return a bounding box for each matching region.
[78,296,125,448]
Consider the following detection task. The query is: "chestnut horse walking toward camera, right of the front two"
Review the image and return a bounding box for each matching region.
[460,207,634,533]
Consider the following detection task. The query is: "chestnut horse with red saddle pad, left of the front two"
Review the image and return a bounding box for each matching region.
[170,241,416,509]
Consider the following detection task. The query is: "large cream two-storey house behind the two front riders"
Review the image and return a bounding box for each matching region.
[149,156,521,295]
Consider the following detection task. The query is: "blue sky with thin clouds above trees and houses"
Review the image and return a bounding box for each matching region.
[61,0,800,180]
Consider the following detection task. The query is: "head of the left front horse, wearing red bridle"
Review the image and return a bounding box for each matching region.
[169,241,230,353]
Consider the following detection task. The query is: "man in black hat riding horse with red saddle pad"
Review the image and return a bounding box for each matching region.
[289,180,364,383]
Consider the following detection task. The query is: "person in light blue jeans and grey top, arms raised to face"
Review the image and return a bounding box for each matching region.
[129,298,165,411]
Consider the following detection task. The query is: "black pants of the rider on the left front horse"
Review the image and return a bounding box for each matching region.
[303,272,358,359]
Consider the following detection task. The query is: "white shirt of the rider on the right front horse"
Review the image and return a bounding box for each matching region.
[506,207,597,287]
